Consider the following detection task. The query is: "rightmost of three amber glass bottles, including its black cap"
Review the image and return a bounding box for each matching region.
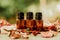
[35,12,43,31]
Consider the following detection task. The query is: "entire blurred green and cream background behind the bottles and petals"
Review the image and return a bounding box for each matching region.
[0,0,60,23]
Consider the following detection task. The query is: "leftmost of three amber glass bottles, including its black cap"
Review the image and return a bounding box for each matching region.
[17,12,25,29]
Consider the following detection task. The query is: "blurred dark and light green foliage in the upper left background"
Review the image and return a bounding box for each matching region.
[0,0,39,19]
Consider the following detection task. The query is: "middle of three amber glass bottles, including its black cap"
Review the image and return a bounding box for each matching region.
[26,12,34,30]
